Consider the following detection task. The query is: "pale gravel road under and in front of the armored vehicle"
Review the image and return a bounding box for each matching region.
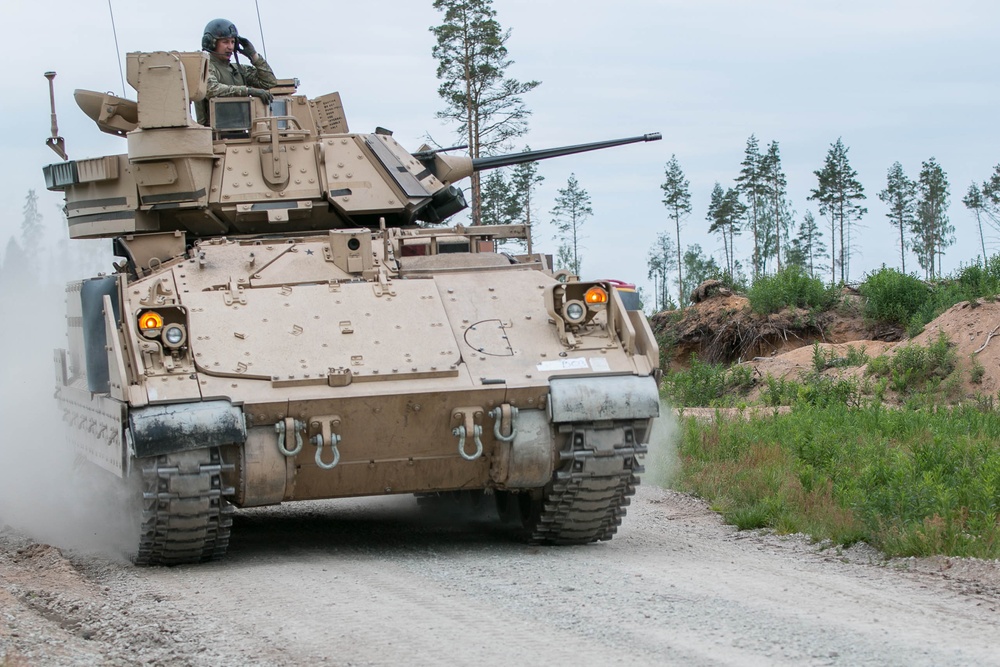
[0,487,1000,667]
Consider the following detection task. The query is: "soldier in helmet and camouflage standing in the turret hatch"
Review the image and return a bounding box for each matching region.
[195,19,278,125]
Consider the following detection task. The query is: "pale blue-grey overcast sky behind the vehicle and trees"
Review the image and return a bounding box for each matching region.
[7,0,1000,298]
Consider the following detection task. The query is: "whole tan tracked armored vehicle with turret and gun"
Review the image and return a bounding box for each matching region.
[44,52,659,565]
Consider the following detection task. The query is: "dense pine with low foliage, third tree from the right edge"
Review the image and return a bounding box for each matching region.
[913,157,955,280]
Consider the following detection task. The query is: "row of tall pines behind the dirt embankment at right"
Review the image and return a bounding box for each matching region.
[647,135,968,310]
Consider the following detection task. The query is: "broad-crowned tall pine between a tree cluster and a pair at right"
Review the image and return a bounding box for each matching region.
[809,138,868,283]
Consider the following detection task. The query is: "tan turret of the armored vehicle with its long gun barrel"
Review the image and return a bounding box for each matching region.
[44,52,660,238]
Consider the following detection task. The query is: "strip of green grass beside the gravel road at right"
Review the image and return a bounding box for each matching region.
[677,402,1000,558]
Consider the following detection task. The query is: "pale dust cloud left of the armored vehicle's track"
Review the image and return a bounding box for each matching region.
[0,272,134,559]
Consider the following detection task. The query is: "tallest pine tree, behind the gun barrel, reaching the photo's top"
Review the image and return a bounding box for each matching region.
[430,0,540,225]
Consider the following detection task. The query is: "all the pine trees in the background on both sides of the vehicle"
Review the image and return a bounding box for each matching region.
[17,0,1000,310]
